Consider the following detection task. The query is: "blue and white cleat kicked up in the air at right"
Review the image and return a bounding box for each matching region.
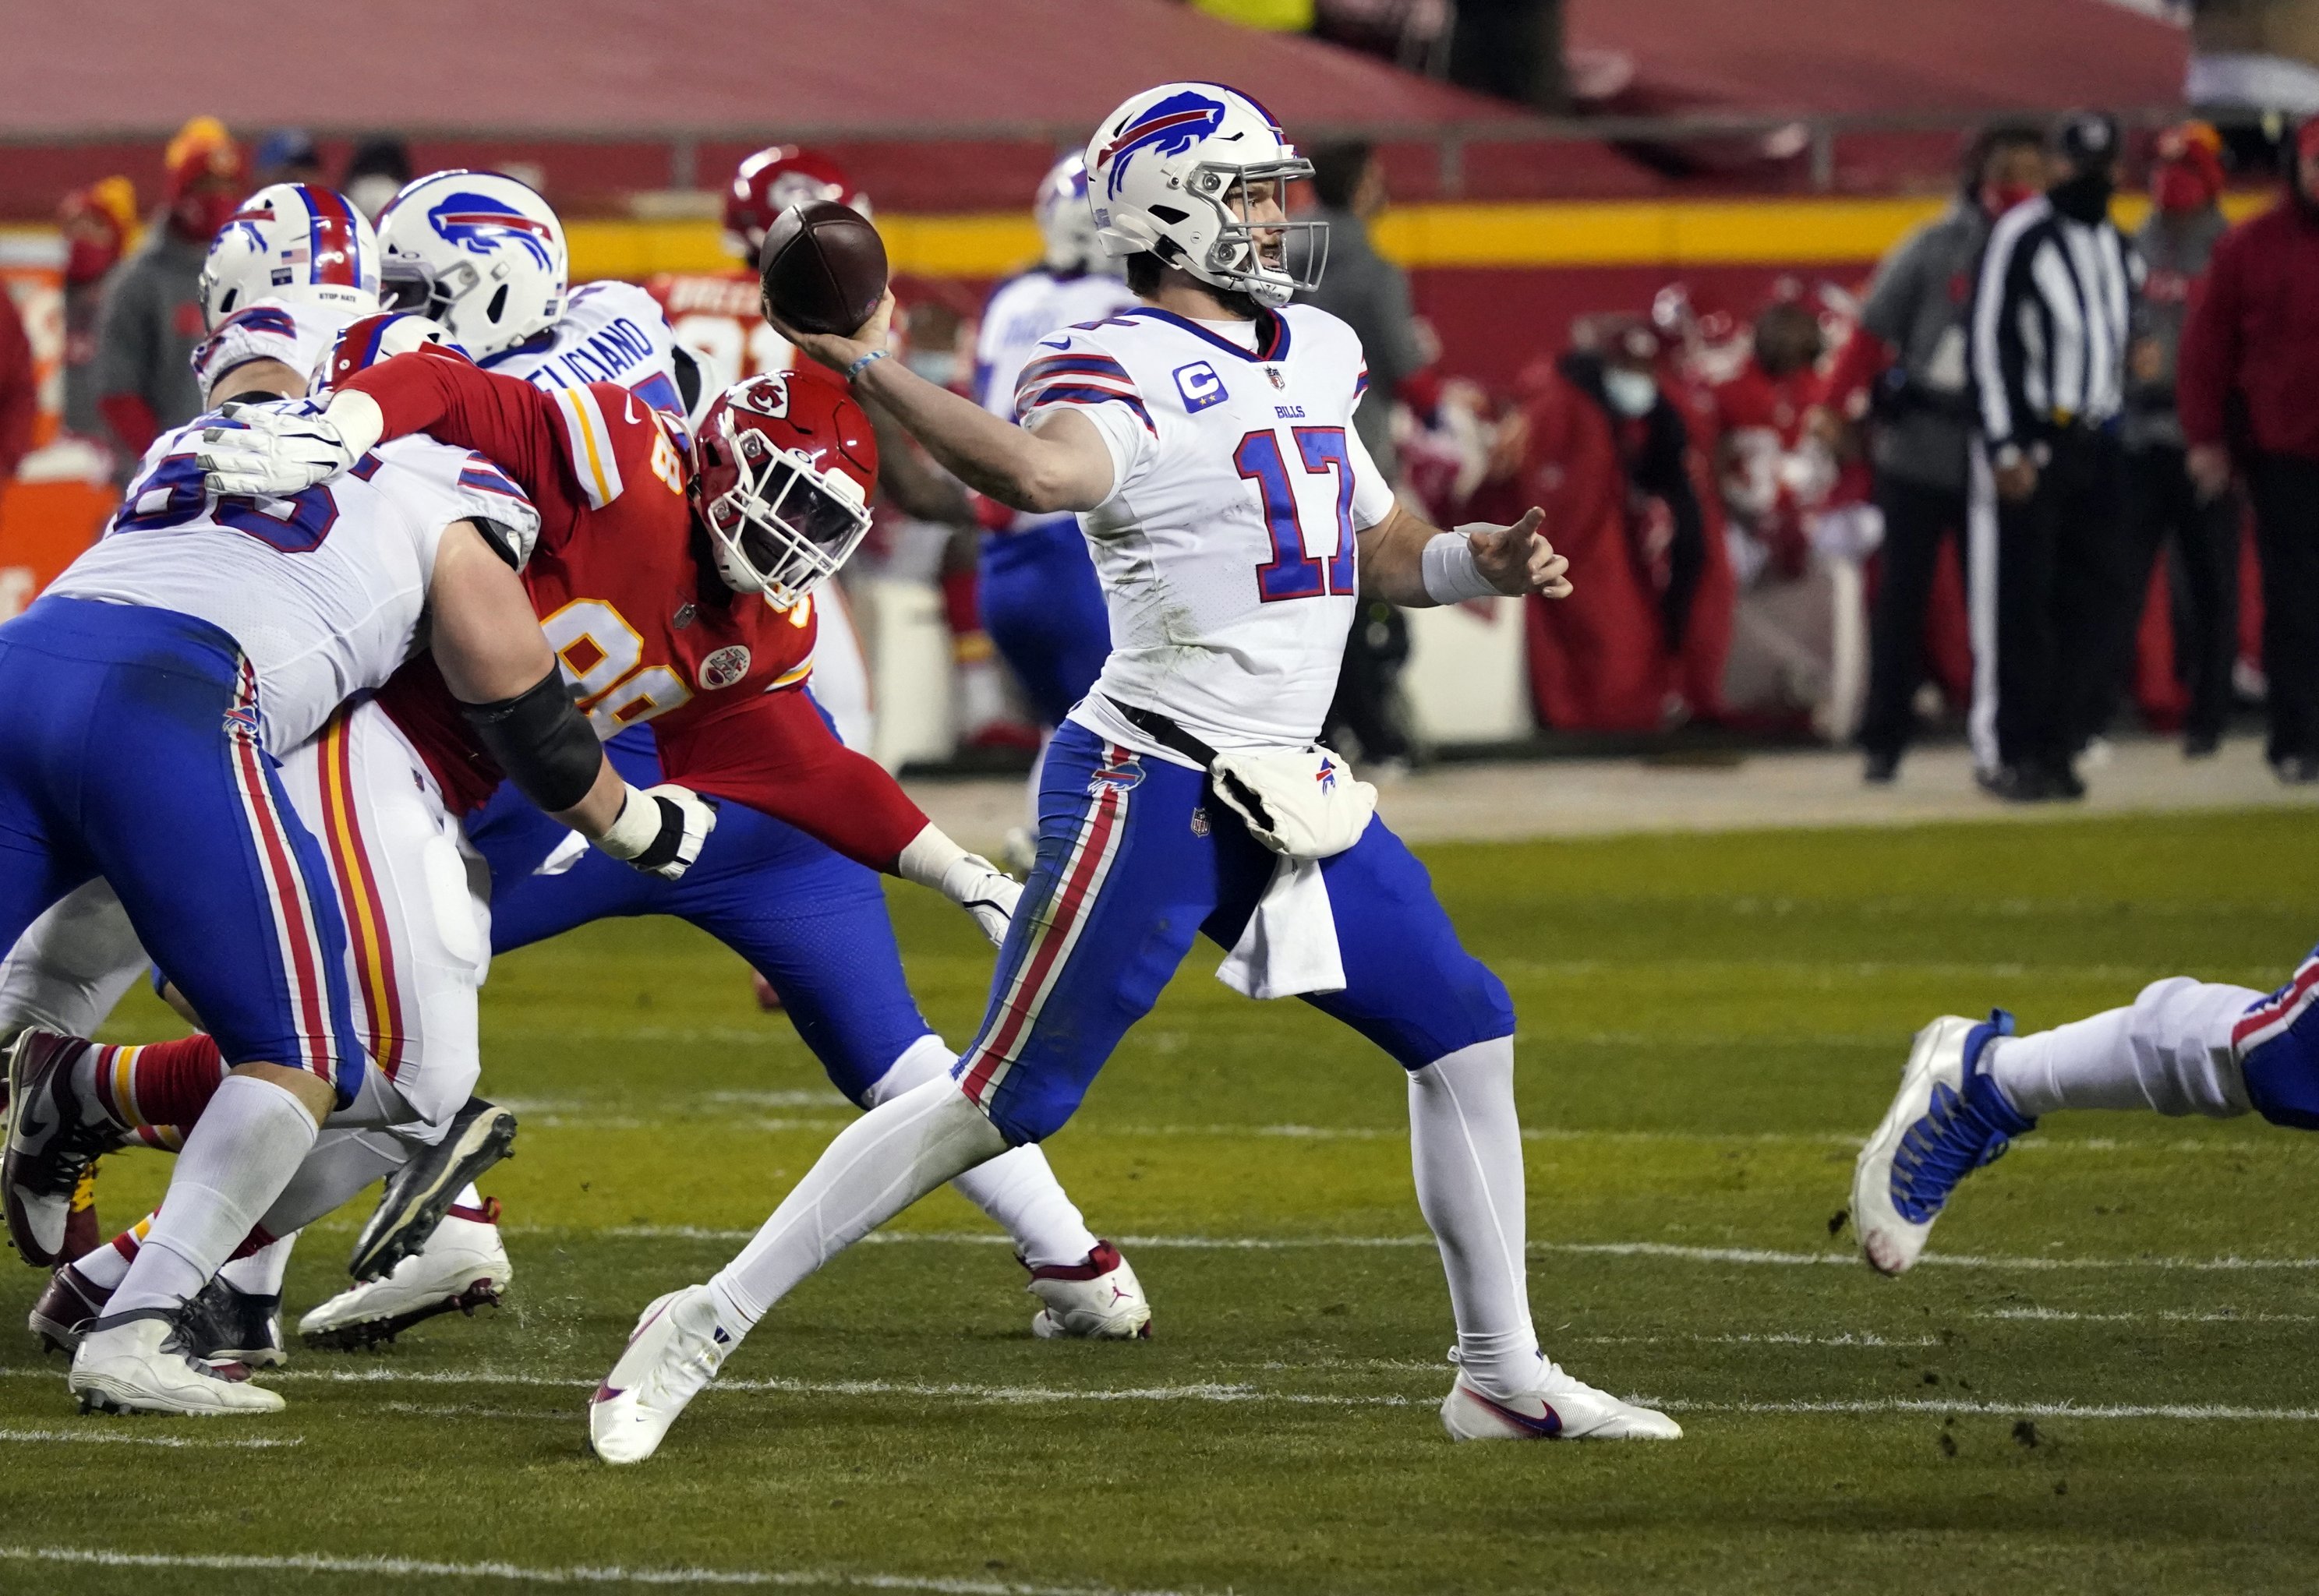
[1853,1009,2036,1273]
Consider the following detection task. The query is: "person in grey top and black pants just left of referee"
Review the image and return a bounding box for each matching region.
[1827,123,2045,782]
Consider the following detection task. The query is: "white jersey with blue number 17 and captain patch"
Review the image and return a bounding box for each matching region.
[1016,304,1394,763]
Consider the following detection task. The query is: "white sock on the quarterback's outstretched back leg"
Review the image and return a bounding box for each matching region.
[709,1076,1006,1332]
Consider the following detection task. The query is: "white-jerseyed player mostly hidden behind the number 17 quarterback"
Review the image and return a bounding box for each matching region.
[974,150,1137,860]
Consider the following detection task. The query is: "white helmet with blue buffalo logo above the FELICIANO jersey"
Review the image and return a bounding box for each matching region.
[378,171,571,359]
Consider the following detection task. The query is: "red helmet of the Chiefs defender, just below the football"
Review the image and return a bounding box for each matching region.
[694,366,877,610]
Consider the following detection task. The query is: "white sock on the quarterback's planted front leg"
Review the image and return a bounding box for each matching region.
[1410,1037,1544,1396]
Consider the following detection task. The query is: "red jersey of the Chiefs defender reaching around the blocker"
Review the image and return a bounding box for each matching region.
[348,355,925,867]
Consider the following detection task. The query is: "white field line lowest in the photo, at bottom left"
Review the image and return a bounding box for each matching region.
[0,1545,1178,1596]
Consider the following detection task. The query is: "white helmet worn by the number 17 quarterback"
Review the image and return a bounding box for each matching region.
[1085,83,1329,306]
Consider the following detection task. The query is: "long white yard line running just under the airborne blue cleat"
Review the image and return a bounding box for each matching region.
[533,1225,2319,1273]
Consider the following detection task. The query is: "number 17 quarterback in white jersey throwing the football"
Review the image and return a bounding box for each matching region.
[589,83,1681,1461]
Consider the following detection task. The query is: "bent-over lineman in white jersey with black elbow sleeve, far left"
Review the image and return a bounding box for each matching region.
[0,343,709,1413]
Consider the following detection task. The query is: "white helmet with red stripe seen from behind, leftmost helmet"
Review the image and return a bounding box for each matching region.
[200,183,378,332]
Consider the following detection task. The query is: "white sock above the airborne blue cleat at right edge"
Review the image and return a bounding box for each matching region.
[1985,976,2261,1118]
